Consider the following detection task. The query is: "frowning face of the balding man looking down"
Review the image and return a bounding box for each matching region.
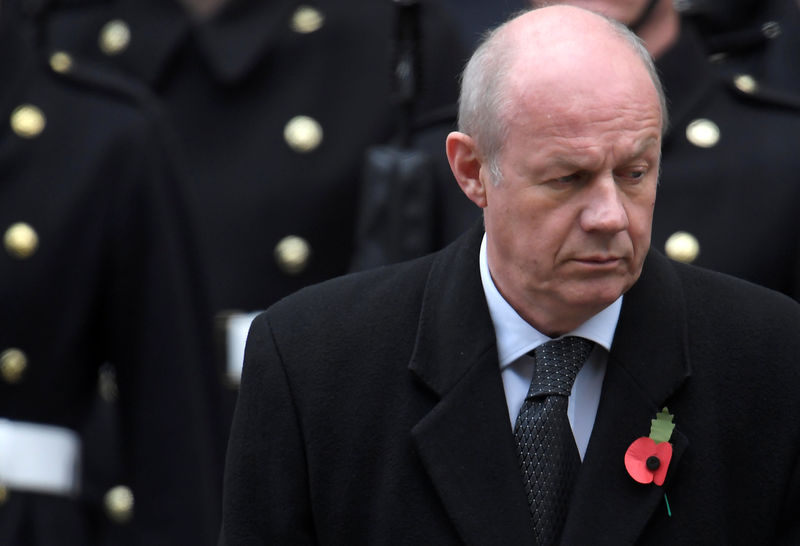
[482,59,661,335]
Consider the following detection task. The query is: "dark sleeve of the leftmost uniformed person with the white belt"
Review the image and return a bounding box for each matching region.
[105,112,222,545]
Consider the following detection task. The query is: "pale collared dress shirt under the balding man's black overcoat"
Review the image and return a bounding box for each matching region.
[480,234,622,460]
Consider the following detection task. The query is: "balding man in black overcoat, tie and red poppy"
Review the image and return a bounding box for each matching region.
[220,6,800,545]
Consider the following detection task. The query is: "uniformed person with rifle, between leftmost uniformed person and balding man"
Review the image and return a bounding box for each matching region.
[34,0,466,384]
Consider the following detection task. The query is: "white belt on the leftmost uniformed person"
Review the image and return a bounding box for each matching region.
[0,418,81,496]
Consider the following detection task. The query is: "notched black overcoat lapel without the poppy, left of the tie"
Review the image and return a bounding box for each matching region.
[410,220,533,544]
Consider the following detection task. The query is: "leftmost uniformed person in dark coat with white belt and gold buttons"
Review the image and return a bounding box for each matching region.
[0,2,219,546]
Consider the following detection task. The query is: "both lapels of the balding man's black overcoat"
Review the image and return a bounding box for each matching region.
[410,223,689,544]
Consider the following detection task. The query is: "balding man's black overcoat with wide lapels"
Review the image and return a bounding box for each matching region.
[220,219,800,546]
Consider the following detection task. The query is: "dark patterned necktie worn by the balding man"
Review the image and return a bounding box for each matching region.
[514,336,594,546]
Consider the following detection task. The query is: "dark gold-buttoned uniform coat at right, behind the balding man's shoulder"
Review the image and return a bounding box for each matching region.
[653,22,800,300]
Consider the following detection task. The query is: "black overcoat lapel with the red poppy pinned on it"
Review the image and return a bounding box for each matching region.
[562,251,690,544]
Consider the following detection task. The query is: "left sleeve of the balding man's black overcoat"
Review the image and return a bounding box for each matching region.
[219,314,316,546]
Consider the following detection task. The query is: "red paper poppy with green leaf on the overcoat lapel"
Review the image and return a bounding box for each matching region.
[625,408,675,516]
